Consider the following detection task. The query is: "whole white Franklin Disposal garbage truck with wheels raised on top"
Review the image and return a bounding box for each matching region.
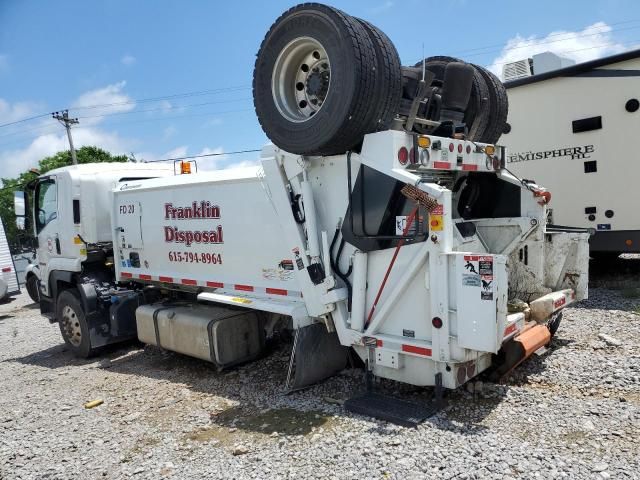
[15,4,588,424]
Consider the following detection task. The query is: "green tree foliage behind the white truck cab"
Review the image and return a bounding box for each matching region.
[0,147,129,253]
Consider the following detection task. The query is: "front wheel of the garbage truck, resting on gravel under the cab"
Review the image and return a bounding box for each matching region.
[56,290,95,358]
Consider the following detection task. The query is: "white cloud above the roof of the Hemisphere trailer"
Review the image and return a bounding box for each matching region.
[488,22,629,76]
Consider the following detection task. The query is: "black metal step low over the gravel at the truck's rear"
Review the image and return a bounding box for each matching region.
[344,392,440,428]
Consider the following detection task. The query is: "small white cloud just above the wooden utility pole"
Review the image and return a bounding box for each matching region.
[71,80,136,125]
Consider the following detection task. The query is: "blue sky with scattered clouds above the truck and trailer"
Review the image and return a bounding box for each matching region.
[0,0,640,176]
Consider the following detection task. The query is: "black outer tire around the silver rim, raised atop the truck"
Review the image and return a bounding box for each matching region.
[253,3,376,155]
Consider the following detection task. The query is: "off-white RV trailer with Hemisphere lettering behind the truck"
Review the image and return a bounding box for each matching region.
[501,50,640,256]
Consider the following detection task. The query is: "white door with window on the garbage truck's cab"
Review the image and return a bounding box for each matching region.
[33,175,62,296]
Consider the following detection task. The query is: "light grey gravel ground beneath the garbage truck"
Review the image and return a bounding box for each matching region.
[0,289,640,480]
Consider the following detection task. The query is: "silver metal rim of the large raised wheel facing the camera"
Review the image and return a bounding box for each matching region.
[271,37,331,123]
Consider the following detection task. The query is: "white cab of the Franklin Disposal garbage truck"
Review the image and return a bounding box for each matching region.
[16,163,174,332]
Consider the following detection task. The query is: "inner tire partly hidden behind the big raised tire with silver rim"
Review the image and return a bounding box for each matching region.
[356,18,402,133]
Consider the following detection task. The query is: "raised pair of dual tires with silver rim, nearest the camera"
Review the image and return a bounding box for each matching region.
[253,3,402,155]
